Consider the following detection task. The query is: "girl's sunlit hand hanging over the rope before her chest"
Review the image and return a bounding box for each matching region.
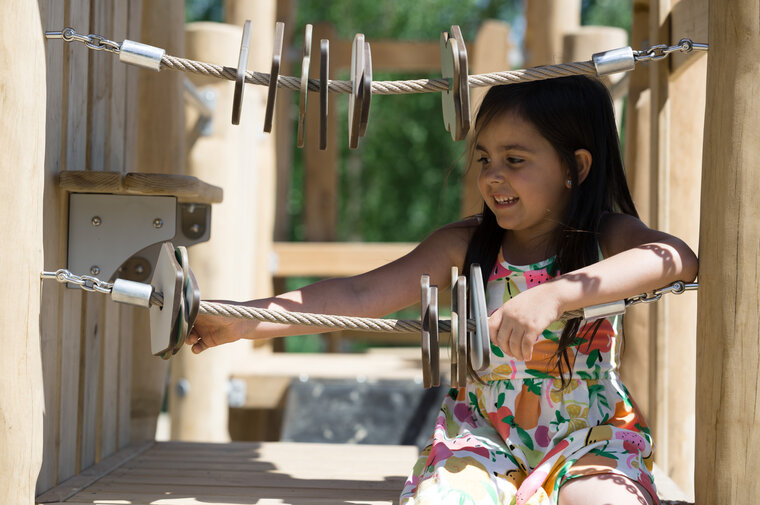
[488,285,562,361]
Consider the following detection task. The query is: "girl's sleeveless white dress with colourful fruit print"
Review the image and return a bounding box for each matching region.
[400,255,659,505]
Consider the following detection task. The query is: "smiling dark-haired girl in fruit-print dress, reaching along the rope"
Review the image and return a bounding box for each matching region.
[188,77,697,505]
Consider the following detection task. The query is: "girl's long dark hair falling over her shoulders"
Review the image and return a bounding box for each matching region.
[464,76,638,384]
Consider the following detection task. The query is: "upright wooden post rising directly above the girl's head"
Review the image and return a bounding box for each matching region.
[525,0,581,67]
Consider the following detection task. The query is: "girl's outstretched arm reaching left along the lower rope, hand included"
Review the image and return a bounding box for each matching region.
[187,220,475,353]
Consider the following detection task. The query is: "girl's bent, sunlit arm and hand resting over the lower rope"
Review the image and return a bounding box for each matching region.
[489,214,697,359]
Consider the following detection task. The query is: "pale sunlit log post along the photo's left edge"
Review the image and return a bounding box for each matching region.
[0,0,46,504]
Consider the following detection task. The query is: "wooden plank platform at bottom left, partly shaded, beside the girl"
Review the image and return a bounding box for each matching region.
[37,442,417,505]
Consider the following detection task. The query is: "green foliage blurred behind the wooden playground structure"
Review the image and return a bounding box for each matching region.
[186,0,631,242]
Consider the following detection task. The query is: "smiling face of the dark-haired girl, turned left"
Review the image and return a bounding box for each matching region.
[475,112,570,252]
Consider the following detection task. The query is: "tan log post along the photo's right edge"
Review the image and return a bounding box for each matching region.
[695,0,760,505]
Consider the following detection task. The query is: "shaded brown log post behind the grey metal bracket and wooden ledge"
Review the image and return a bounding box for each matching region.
[131,2,185,441]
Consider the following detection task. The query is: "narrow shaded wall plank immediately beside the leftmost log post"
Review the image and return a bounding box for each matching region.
[36,0,66,493]
